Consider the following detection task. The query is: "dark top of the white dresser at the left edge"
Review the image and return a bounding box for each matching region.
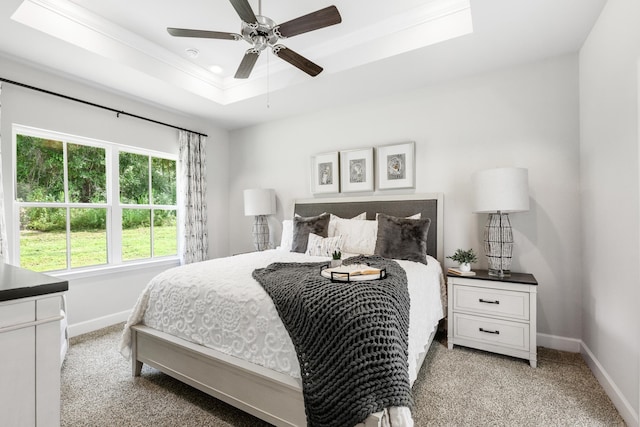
[0,262,69,302]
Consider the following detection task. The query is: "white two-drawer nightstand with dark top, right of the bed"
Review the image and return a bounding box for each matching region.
[447,270,538,368]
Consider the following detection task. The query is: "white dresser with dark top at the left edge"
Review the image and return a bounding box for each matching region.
[0,263,68,427]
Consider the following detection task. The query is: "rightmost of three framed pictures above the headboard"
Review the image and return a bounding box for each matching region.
[376,142,416,190]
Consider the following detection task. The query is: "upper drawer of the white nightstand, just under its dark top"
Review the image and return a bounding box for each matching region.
[453,285,529,320]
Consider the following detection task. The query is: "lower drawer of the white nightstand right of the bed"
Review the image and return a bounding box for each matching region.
[453,313,529,351]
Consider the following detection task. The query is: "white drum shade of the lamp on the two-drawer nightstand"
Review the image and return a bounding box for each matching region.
[473,168,529,213]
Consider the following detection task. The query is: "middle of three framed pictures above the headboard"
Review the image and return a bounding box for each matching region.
[340,147,375,193]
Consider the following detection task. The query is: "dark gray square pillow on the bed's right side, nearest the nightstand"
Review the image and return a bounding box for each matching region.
[374,214,431,264]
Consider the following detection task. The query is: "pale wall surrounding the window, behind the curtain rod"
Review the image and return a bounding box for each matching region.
[0,57,229,334]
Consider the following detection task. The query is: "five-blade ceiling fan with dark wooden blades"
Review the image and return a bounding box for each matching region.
[167,0,342,79]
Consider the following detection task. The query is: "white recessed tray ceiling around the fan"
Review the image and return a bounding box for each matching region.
[0,0,605,128]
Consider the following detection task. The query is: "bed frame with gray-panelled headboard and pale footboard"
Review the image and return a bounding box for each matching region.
[131,193,444,427]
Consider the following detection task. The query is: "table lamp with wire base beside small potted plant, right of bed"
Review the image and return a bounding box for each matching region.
[473,168,529,278]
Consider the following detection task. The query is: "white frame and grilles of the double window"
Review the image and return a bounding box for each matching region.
[9,124,181,277]
